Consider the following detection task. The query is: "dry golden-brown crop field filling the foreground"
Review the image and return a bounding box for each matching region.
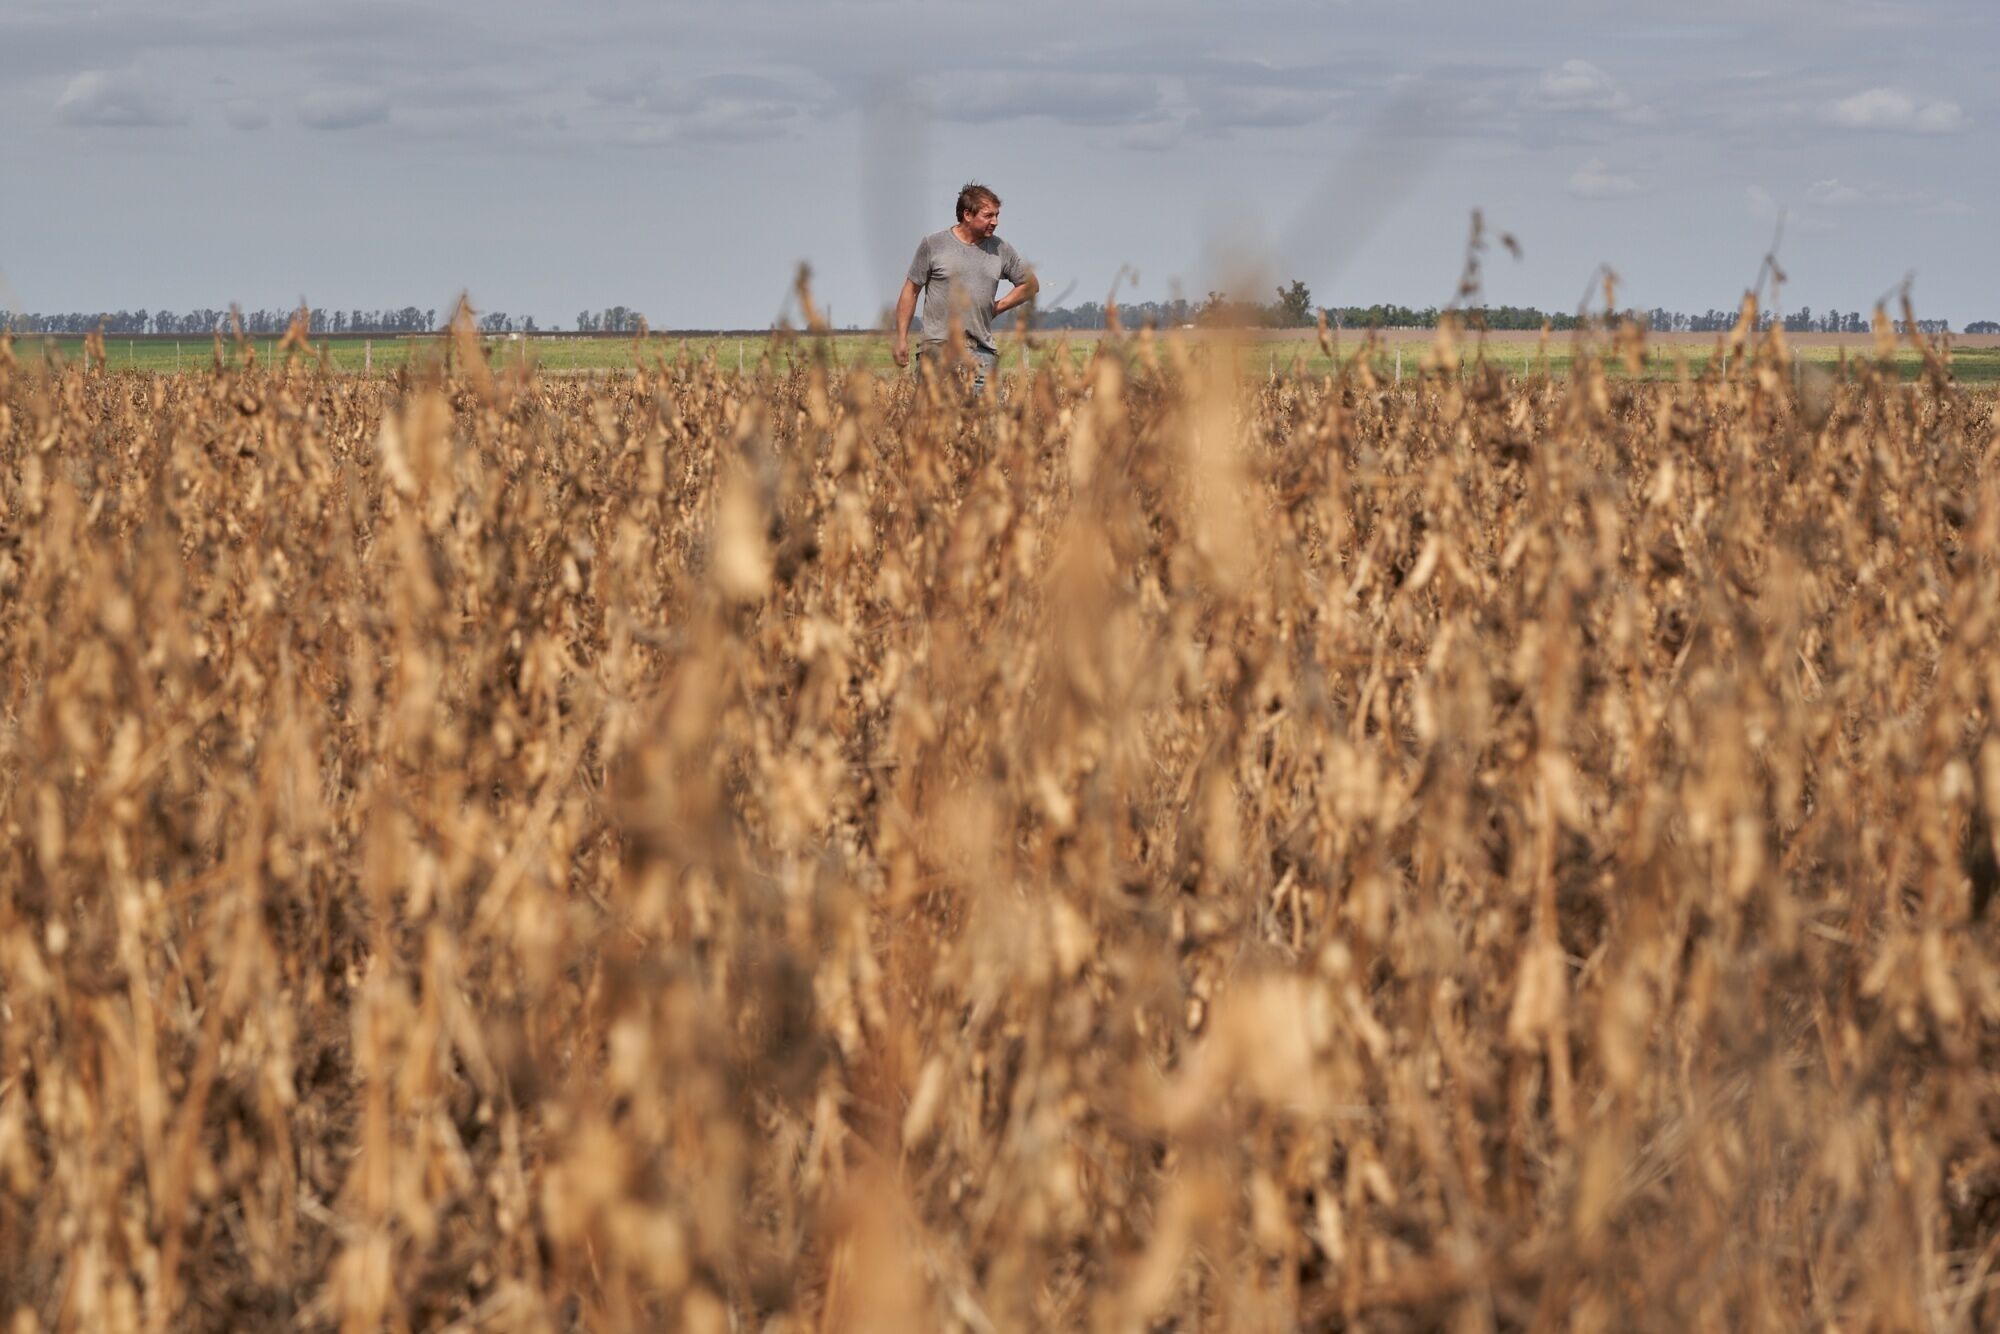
[0,318,2000,1334]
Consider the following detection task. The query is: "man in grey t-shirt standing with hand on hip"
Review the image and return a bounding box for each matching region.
[896,182,1042,394]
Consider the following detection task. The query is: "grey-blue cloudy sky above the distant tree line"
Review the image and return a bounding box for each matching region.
[0,0,2000,328]
